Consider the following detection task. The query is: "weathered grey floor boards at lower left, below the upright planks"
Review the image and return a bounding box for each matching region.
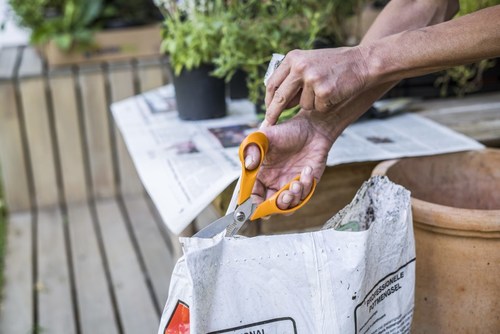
[0,197,177,333]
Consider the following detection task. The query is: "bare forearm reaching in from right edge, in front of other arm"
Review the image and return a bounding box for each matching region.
[360,5,500,85]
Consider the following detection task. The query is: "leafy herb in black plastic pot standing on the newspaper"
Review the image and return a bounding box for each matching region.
[155,0,226,120]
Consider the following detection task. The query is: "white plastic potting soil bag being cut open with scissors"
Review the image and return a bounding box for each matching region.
[159,176,415,334]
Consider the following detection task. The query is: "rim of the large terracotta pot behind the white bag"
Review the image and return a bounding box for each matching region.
[372,159,500,234]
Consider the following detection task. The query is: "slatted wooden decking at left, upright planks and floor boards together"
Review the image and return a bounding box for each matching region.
[0,48,207,334]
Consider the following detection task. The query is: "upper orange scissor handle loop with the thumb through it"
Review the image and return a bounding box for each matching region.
[238,131,269,205]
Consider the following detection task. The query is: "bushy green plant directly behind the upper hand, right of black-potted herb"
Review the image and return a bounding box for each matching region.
[214,0,360,102]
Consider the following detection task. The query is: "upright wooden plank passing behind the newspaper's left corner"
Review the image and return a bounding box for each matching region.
[109,65,144,195]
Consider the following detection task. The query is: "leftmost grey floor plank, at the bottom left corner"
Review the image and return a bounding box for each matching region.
[0,212,33,333]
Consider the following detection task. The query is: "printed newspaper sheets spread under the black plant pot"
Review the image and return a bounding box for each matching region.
[111,85,483,234]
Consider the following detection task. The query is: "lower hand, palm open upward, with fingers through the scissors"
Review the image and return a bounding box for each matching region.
[244,111,333,210]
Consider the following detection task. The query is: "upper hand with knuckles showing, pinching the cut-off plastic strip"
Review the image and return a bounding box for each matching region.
[264,46,368,126]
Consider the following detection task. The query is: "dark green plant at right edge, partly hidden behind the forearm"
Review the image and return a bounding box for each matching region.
[434,0,500,96]
